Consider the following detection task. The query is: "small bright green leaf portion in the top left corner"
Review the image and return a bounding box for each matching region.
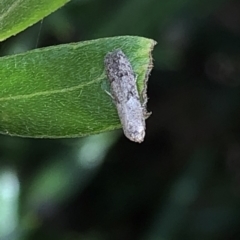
[0,0,70,41]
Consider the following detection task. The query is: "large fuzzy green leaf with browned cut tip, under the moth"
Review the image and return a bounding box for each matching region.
[0,36,155,138]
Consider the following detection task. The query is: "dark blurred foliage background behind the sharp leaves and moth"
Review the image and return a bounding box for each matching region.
[0,0,240,240]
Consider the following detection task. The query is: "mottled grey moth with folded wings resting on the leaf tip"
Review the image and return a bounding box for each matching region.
[104,49,146,143]
